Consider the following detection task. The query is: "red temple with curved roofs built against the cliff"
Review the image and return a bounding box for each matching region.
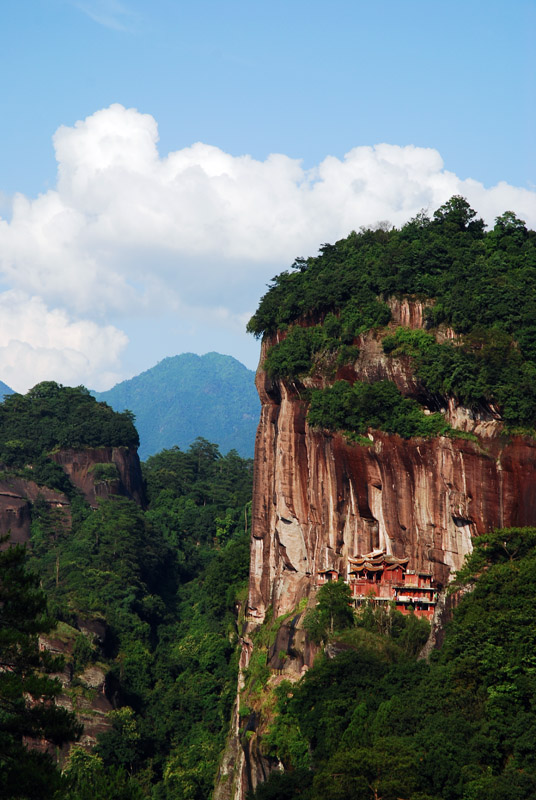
[317,550,438,619]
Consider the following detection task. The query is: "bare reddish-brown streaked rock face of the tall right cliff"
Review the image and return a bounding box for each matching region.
[223,300,536,799]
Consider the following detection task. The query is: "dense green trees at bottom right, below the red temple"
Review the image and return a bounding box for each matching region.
[254,529,536,800]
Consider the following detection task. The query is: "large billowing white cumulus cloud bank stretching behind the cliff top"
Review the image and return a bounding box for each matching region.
[0,104,536,390]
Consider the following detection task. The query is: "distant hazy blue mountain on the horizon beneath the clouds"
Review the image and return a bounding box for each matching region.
[92,353,260,460]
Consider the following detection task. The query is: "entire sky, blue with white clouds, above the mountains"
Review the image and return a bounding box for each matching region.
[0,0,536,390]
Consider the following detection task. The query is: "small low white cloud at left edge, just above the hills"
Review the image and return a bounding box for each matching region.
[0,290,128,392]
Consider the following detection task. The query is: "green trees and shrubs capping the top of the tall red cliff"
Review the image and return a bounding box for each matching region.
[248,197,536,432]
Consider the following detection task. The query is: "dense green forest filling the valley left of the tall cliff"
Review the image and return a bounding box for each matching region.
[0,383,252,800]
